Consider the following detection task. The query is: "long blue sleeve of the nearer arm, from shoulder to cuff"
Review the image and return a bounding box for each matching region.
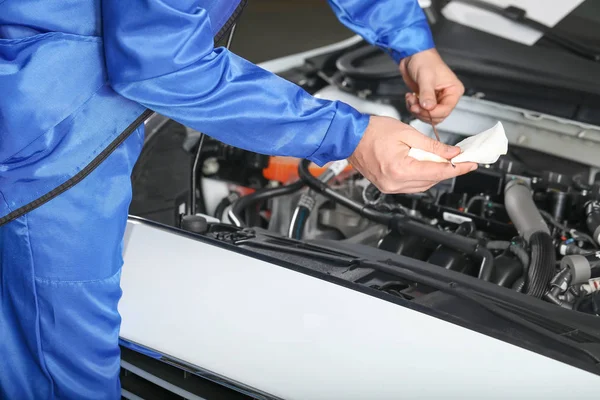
[102,0,369,165]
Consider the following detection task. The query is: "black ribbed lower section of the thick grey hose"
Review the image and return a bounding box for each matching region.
[525,232,556,298]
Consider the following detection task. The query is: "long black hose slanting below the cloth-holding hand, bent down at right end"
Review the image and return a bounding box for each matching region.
[298,160,494,281]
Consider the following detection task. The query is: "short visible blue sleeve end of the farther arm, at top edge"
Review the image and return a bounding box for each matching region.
[327,0,434,63]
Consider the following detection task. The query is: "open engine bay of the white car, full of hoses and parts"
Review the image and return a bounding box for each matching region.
[134,36,600,324]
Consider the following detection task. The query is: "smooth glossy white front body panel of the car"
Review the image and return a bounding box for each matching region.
[119,221,600,400]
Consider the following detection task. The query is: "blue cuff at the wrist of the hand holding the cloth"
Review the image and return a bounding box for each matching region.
[308,101,371,167]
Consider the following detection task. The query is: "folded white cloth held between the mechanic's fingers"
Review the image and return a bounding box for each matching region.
[408,122,508,164]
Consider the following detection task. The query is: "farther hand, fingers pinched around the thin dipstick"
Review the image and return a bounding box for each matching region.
[400,49,465,124]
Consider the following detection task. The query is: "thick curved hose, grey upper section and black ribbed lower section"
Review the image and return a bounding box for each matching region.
[504,179,556,298]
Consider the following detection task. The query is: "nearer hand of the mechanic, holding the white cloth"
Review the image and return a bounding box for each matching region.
[348,117,477,193]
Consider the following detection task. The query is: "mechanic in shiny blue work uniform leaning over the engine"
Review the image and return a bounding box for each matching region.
[0,0,476,400]
